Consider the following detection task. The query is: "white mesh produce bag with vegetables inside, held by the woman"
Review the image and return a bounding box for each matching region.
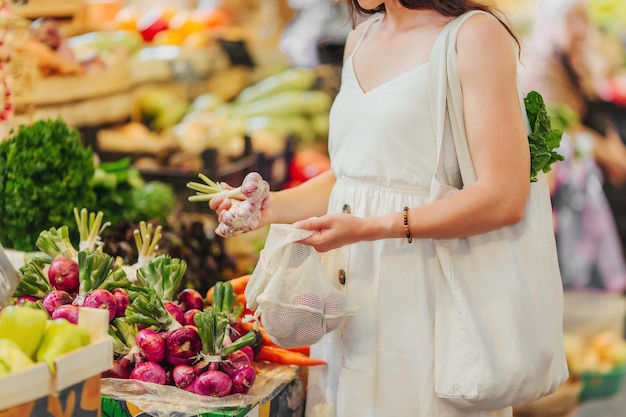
[245,224,355,347]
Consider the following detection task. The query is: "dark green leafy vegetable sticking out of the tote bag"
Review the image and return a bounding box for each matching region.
[524,91,564,182]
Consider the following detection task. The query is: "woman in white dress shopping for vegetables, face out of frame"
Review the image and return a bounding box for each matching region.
[210,0,548,417]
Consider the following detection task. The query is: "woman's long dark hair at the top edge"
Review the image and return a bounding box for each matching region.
[344,0,520,46]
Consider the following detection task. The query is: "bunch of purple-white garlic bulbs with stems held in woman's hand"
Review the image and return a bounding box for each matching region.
[187,172,270,237]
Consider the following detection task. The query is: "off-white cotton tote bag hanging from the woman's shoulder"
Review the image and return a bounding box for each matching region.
[430,12,568,410]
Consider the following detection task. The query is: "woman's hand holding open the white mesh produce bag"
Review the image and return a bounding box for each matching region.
[294,213,365,252]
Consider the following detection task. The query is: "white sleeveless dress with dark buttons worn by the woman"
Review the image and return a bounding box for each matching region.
[306,13,512,417]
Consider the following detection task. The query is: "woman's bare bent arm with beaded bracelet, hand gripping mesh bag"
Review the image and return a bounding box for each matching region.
[300,14,530,251]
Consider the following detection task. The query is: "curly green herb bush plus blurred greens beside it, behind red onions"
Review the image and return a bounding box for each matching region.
[0,119,177,251]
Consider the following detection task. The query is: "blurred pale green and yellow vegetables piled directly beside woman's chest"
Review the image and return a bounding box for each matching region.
[173,68,332,155]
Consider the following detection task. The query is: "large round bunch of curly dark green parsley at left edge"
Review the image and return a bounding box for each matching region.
[0,119,96,251]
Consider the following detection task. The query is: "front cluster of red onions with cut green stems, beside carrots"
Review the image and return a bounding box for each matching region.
[106,283,257,397]
